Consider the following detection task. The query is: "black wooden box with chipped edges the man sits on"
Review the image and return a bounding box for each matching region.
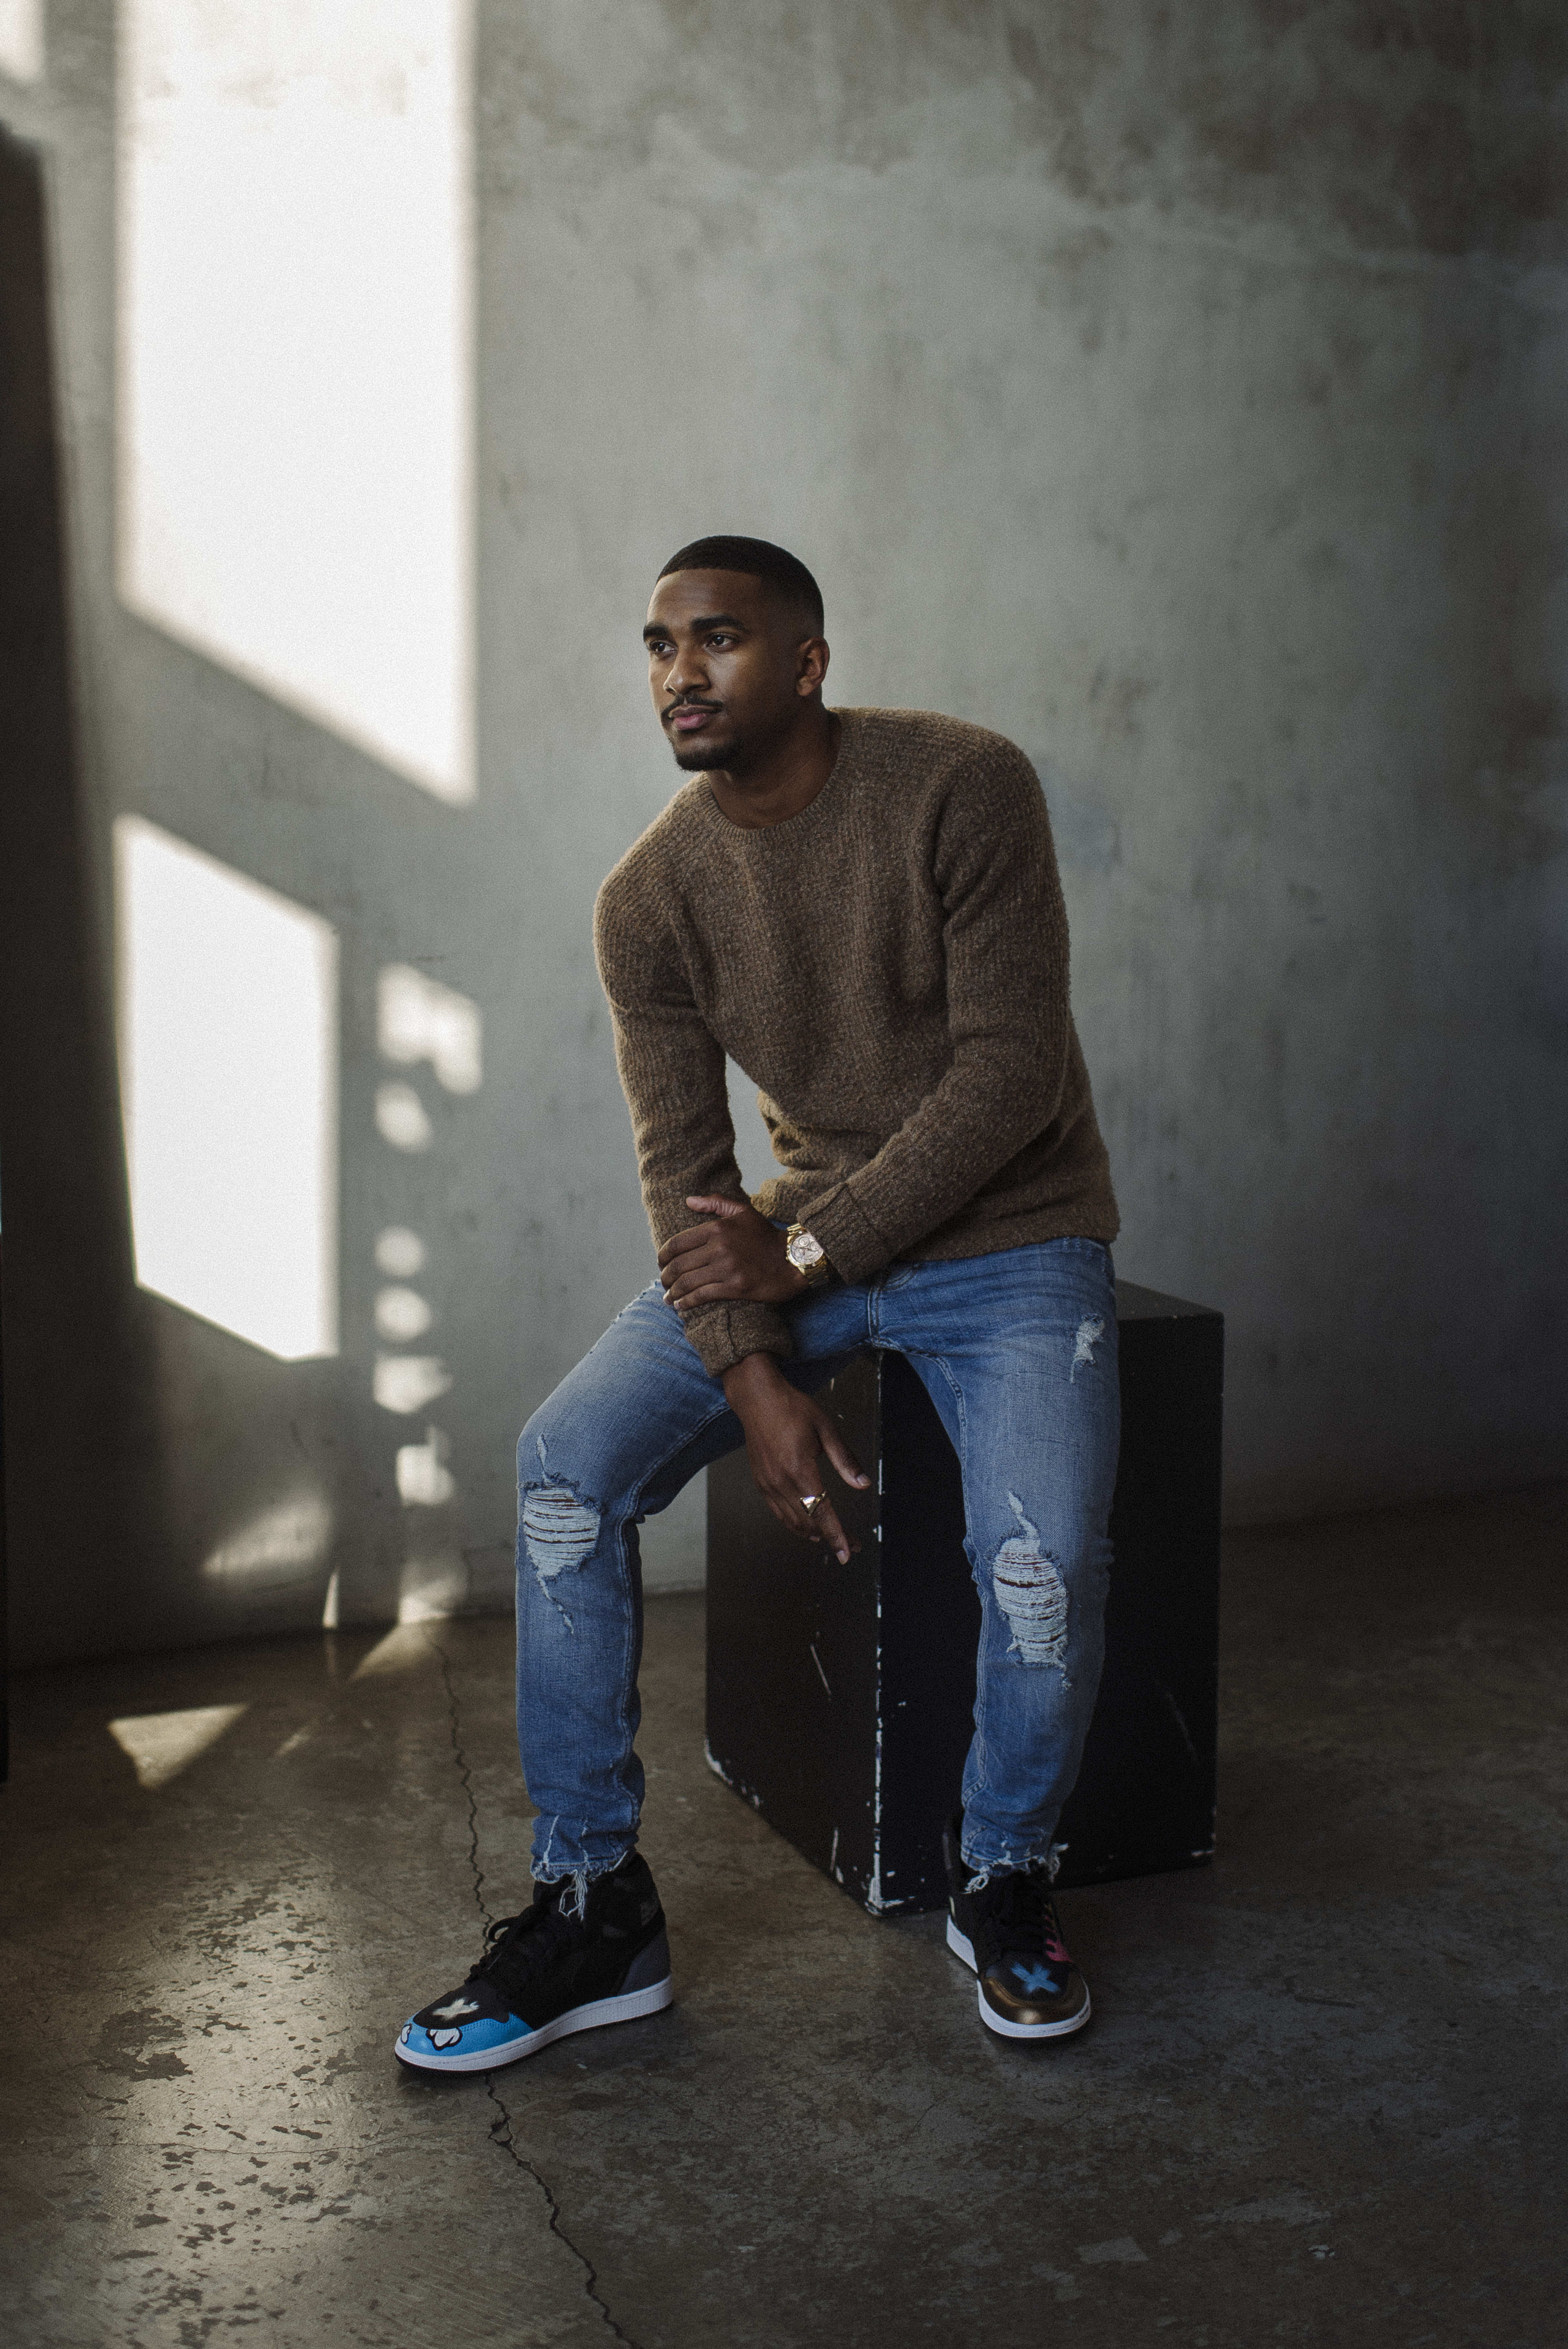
[706,1280,1225,1912]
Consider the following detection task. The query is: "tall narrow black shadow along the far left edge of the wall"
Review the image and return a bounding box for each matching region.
[0,134,162,1654]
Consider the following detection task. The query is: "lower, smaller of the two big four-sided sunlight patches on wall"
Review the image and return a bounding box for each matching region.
[115,815,338,1362]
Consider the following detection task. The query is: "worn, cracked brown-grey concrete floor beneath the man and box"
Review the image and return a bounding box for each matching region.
[0,1492,1568,2349]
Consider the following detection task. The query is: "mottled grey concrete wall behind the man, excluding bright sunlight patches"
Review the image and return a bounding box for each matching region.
[0,0,1568,1682]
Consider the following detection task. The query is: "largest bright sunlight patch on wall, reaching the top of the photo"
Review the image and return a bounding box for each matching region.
[117,0,474,801]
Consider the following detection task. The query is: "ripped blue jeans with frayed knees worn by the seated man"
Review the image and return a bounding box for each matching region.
[517,1240,1122,1884]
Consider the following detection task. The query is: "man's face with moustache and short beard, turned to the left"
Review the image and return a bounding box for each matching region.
[643,571,829,775]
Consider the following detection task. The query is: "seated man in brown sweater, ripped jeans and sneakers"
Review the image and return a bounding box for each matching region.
[396,538,1120,2072]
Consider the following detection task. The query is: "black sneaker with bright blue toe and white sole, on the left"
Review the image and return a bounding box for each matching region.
[394,1851,674,2072]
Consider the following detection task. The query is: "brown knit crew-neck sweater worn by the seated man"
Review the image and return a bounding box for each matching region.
[594,709,1117,1377]
